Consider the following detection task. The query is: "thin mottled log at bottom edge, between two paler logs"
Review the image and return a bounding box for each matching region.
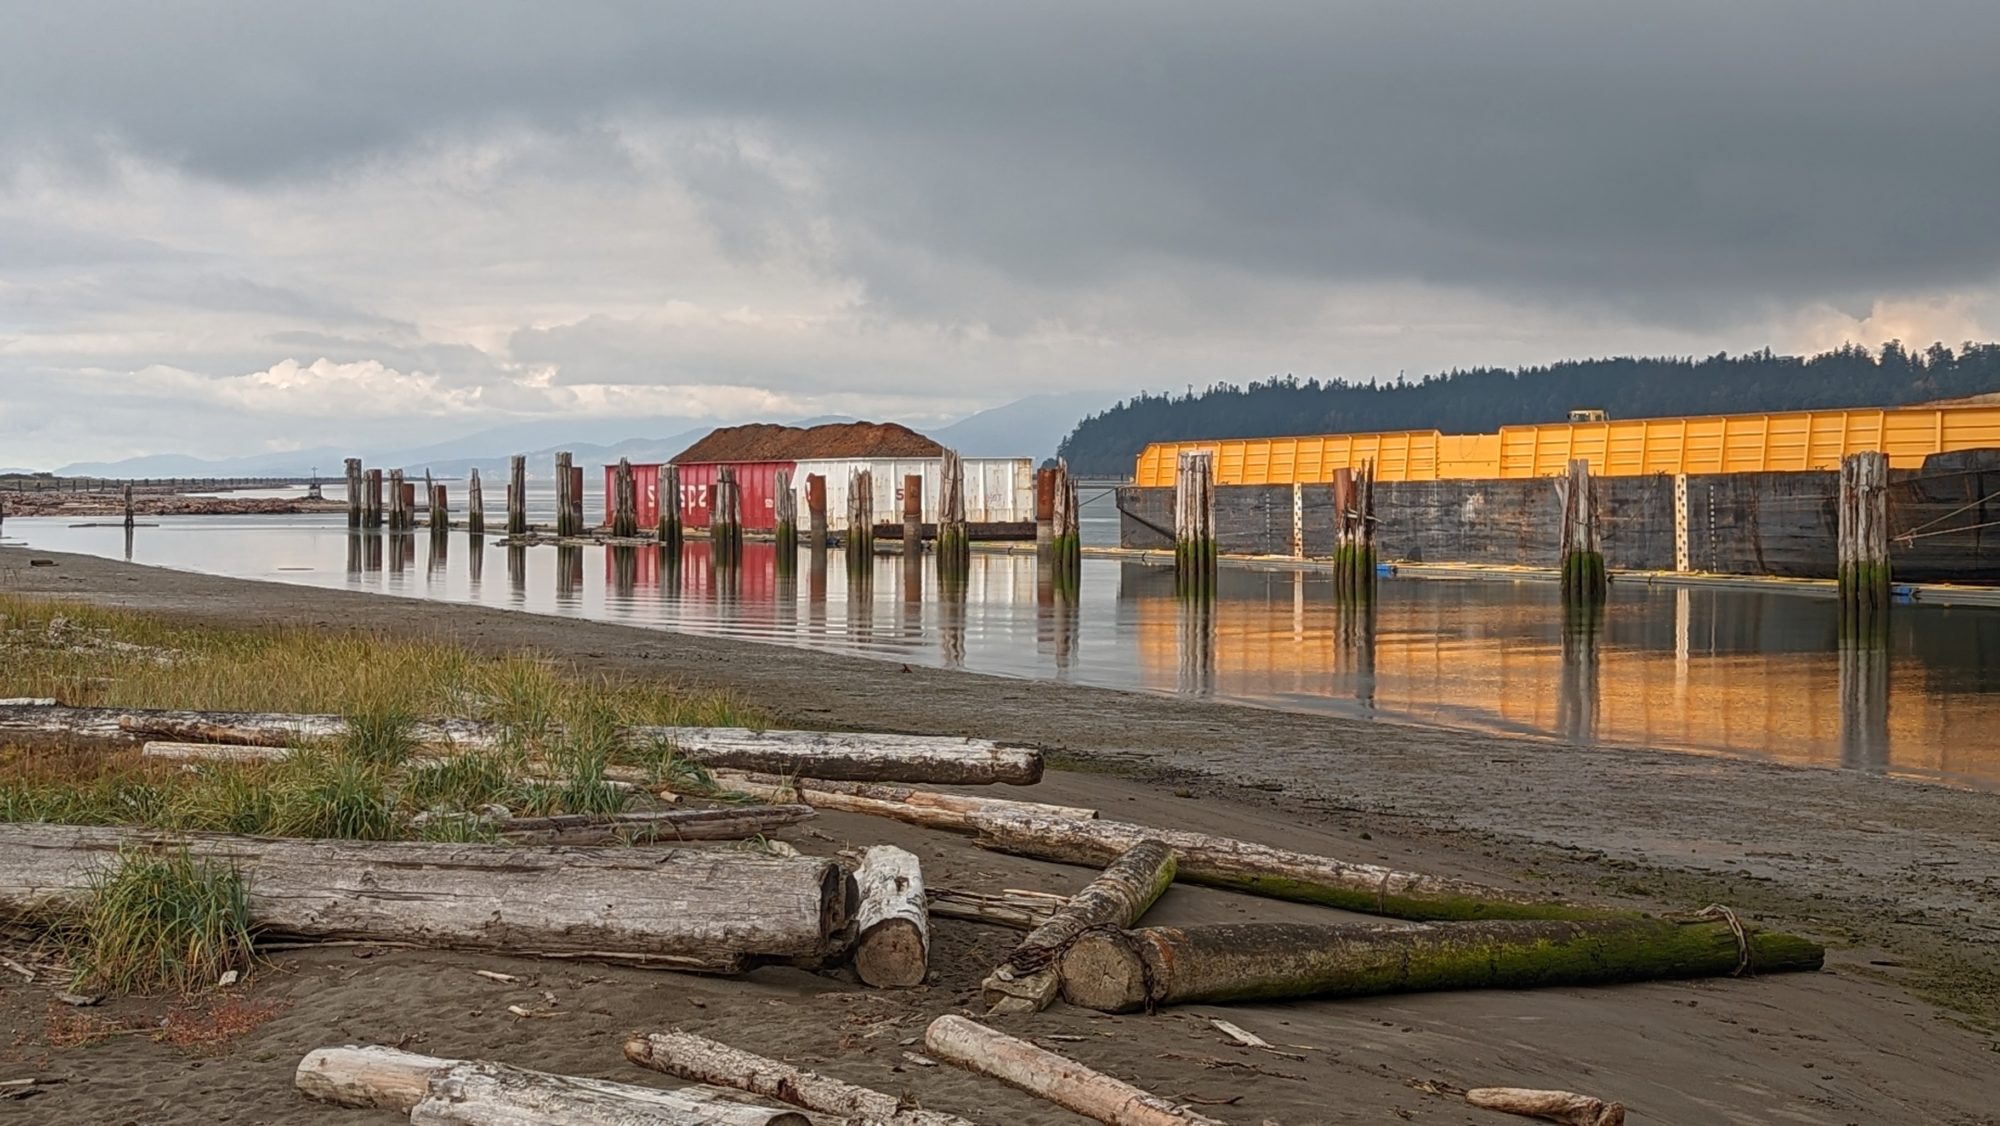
[626,1028,972,1126]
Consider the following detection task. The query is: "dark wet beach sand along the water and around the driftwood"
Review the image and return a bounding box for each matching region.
[0,548,2000,1124]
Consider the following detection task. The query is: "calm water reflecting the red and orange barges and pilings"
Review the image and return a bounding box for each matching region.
[4,500,2000,786]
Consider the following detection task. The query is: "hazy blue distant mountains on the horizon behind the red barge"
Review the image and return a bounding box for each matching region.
[50,392,1118,478]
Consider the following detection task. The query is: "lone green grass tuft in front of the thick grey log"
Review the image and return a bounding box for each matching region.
[64,850,252,994]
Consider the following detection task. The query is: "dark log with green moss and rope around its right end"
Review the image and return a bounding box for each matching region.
[1062,918,1824,1012]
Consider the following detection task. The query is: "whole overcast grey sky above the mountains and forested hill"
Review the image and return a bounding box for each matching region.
[0,0,2000,466]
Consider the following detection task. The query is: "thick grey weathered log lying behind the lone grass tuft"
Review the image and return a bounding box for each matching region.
[0,824,848,972]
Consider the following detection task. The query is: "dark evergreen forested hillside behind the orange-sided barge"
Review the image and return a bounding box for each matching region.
[1060,342,2000,476]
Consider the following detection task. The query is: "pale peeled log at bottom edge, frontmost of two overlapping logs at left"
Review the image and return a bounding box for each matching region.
[410,1062,808,1126]
